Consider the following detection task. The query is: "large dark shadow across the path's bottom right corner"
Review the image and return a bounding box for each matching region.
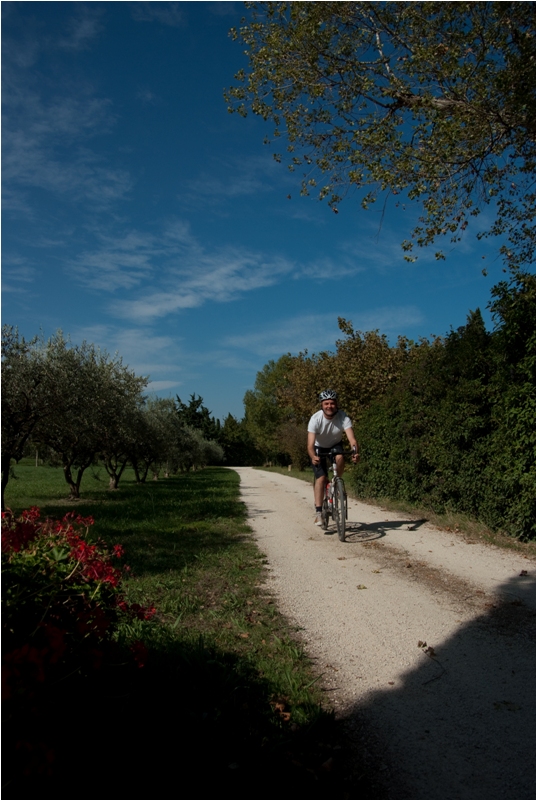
[344,574,536,800]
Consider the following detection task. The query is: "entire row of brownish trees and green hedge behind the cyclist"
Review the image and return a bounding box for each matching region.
[244,270,536,538]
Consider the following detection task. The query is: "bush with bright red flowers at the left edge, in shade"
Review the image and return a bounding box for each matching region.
[2,507,154,698]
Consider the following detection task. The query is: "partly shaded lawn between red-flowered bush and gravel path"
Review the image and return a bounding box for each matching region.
[4,462,351,798]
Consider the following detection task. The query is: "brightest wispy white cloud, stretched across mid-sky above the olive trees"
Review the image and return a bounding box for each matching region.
[67,220,298,323]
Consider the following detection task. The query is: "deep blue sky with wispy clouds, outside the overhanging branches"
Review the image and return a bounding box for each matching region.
[2,2,504,418]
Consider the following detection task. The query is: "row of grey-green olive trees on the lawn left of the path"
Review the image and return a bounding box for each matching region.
[1,326,259,508]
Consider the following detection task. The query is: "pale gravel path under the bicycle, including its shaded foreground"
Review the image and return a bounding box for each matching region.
[236,467,536,800]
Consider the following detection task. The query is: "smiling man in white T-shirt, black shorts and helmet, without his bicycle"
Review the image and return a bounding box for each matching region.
[307,389,359,525]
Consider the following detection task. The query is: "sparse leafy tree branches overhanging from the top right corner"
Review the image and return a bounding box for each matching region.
[225,1,536,266]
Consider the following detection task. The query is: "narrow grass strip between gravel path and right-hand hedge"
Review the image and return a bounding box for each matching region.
[256,467,536,556]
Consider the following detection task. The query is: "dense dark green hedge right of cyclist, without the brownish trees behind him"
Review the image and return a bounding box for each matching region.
[353,273,536,538]
